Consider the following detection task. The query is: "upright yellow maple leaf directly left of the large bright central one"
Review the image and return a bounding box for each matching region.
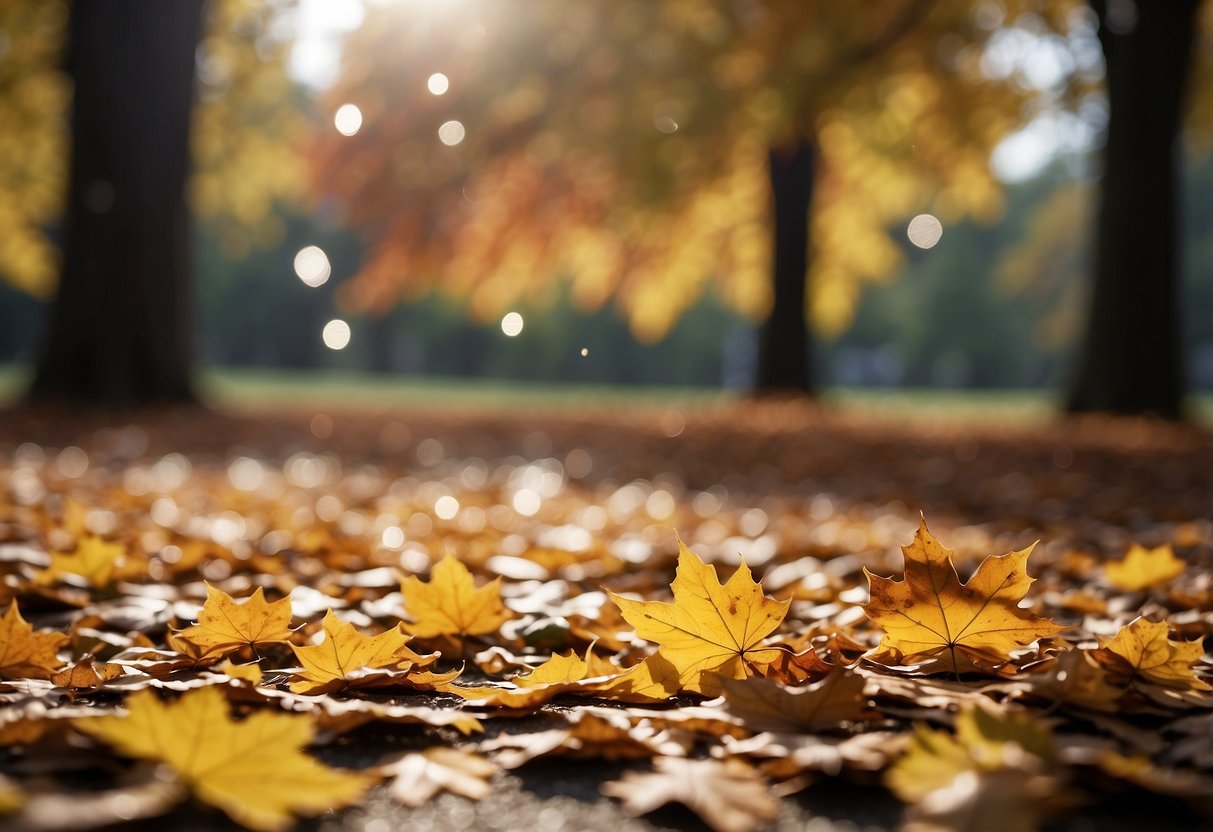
[400,555,513,638]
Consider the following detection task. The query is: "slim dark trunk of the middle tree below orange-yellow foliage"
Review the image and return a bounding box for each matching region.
[754,139,816,395]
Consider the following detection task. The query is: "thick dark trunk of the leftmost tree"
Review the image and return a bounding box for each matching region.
[30,0,204,405]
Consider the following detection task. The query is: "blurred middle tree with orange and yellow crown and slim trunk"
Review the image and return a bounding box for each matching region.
[317,0,1064,391]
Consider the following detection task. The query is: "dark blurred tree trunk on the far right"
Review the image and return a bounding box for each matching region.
[1066,0,1198,418]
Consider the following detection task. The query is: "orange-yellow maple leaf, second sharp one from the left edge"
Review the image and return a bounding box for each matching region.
[170,583,291,657]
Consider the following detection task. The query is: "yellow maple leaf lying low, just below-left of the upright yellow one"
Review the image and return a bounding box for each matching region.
[291,610,454,694]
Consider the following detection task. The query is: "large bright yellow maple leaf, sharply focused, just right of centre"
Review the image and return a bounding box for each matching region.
[610,541,791,694]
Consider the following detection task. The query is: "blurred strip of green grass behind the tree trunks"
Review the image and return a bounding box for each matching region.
[0,365,1213,426]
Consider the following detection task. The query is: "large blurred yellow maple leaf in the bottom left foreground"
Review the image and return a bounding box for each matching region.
[75,686,374,832]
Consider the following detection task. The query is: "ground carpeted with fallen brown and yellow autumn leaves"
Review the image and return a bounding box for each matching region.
[0,403,1213,832]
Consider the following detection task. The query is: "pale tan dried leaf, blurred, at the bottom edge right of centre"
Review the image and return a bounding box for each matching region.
[602,757,779,832]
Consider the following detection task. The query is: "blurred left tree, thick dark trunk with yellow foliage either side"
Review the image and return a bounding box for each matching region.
[0,0,303,404]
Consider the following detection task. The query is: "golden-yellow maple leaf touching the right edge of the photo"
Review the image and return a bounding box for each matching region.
[1092,617,1213,690]
